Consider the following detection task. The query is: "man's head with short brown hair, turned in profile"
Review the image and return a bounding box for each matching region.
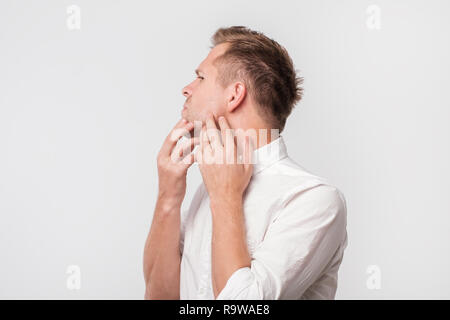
[182,27,303,132]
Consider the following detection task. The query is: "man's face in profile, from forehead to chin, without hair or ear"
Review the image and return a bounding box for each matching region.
[182,44,227,122]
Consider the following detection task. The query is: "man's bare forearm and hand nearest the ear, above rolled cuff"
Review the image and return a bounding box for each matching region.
[196,115,253,298]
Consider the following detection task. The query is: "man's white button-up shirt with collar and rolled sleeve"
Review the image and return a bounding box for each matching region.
[180,135,347,300]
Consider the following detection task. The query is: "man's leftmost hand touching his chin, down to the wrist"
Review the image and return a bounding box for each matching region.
[157,119,199,207]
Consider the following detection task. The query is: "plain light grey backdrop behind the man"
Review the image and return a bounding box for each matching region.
[0,0,450,299]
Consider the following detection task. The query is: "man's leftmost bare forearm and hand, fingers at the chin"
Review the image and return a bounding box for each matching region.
[143,120,199,299]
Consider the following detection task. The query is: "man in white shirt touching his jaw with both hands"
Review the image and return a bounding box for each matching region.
[144,27,347,299]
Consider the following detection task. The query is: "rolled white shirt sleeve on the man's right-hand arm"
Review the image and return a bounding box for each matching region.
[217,185,347,300]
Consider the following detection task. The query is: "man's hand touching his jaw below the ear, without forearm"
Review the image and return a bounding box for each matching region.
[195,114,253,199]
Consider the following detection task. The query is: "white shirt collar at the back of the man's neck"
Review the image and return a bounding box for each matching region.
[252,134,288,175]
